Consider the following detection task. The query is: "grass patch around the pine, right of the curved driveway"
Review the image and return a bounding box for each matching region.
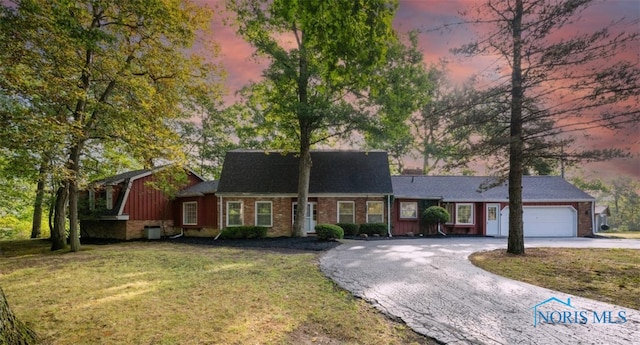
[469,248,640,309]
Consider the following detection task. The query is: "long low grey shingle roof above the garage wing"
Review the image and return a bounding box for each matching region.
[391,176,593,202]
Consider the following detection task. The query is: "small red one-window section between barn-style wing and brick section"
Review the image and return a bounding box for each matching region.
[173,181,220,237]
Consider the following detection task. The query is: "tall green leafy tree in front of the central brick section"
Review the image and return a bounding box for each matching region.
[229,0,397,236]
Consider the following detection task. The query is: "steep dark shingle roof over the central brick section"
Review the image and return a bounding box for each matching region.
[218,150,393,194]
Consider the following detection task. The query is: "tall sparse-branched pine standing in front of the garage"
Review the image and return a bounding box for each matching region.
[454,0,640,254]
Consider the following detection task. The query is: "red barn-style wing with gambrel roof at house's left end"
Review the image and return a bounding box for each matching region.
[80,166,203,240]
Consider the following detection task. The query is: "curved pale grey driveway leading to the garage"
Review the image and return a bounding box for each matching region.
[321,238,640,344]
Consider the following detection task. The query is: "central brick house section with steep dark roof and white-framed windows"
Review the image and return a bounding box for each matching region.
[216,150,393,236]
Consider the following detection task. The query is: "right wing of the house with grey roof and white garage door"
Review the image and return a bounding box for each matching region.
[391,176,595,237]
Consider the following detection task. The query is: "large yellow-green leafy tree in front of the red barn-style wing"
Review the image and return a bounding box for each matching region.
[0,0,225,251]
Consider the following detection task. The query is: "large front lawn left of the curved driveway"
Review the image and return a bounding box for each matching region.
[0,240,434,344]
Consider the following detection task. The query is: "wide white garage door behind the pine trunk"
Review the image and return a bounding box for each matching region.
[500,206,578,237]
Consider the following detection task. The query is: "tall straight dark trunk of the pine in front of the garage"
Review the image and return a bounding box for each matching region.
[507,0,524,255]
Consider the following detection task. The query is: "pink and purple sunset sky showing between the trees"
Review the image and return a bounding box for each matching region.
[194,0,640,181]
